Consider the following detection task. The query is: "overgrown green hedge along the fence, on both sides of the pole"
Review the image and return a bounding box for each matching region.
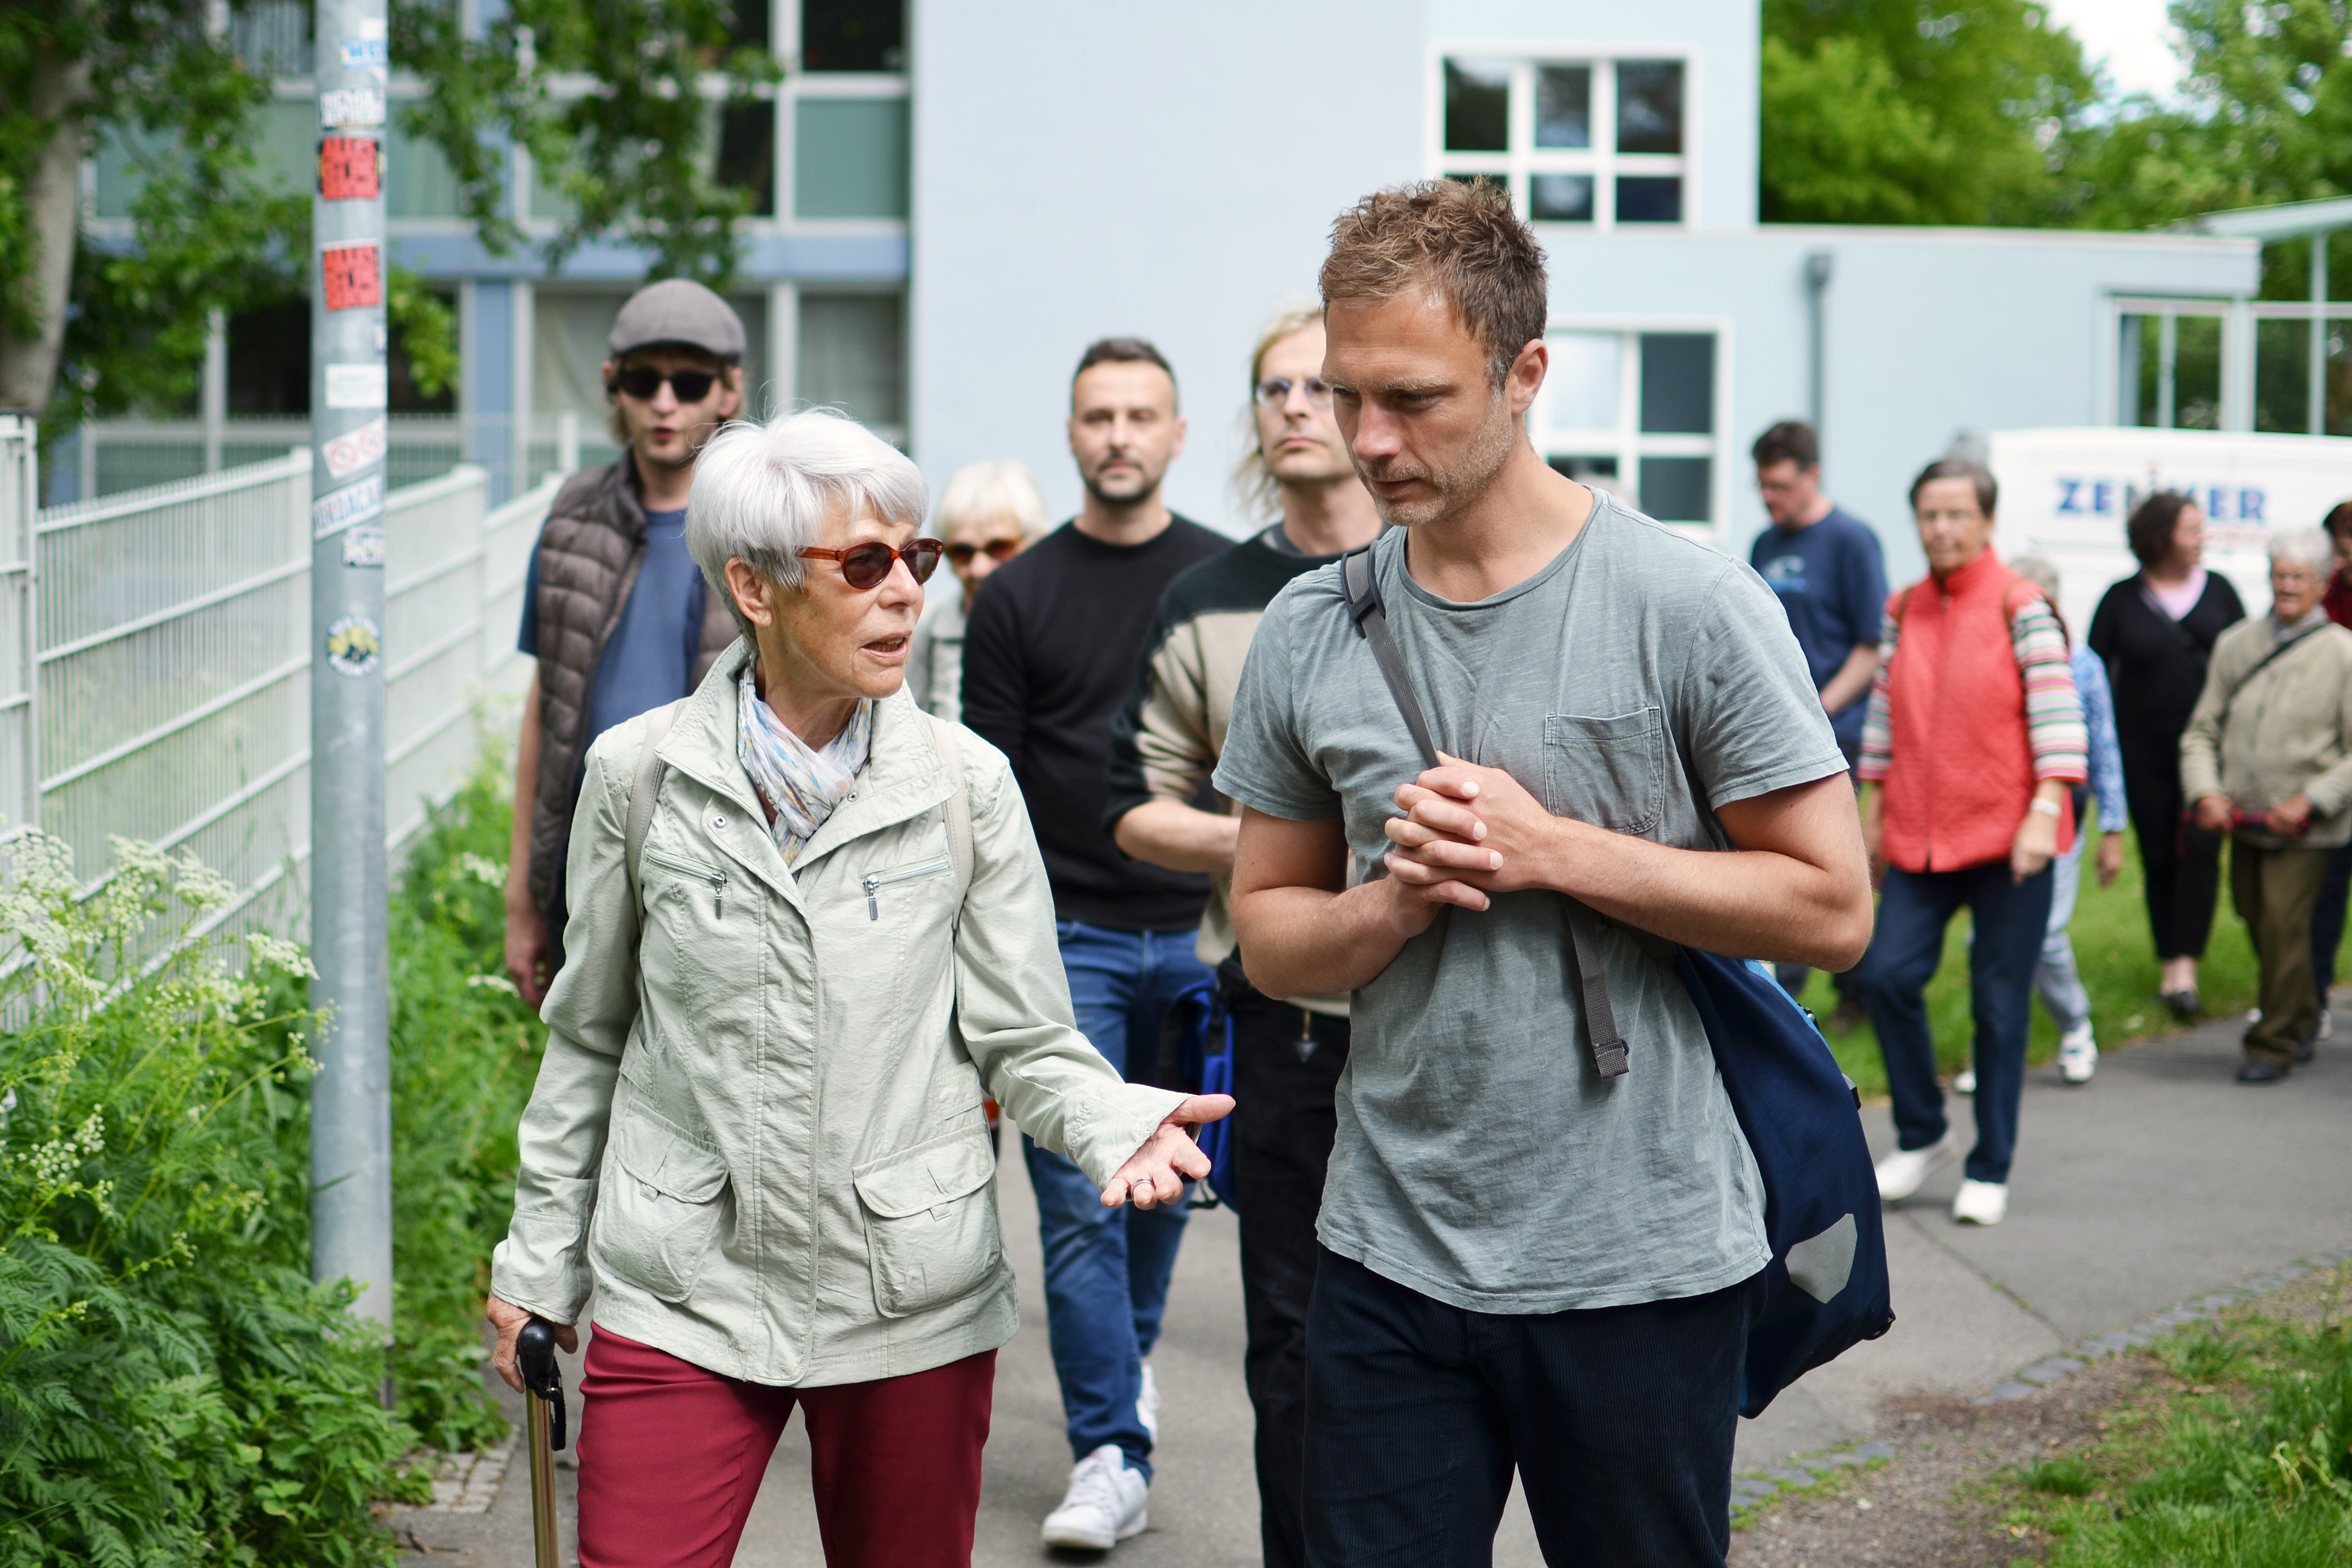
[0,766,539,1568]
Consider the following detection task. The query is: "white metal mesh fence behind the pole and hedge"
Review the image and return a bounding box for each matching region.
[0,416,557,933]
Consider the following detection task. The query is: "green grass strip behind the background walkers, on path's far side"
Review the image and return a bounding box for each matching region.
[1804,832,2286,1095]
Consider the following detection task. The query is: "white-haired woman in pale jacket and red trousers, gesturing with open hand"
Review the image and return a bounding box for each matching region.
[489,411,1233,1568]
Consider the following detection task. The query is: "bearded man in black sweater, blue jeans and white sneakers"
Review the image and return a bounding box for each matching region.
[964,339,1233,1552]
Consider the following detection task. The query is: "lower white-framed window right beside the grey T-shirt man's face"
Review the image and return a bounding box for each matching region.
[1531,327,1724,527]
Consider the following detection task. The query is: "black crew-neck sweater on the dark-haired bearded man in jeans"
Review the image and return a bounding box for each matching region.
[964,517,1233,931]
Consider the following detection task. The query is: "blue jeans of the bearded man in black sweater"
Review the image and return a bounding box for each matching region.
[1021,919,1209,1479]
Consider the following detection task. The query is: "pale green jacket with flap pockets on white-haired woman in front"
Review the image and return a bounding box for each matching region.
[492,642,1181,1387]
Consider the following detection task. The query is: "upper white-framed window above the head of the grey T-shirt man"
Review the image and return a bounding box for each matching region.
[1435,51,1691,228]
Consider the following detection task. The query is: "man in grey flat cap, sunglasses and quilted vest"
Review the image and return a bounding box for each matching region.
[506,278,743,1009]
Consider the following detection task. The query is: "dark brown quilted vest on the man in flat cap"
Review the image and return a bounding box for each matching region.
[532,454,736,931]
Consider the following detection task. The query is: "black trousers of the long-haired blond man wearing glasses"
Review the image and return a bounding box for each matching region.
[1216,959,1348,1568]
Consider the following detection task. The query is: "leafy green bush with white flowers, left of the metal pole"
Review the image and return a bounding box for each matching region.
[0,835,423,1568]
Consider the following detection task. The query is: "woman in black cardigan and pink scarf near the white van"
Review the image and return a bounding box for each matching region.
[2091,494,2246,1018]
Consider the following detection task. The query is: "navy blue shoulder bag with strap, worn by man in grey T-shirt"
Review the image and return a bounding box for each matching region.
[1341,548,1896,1415]
